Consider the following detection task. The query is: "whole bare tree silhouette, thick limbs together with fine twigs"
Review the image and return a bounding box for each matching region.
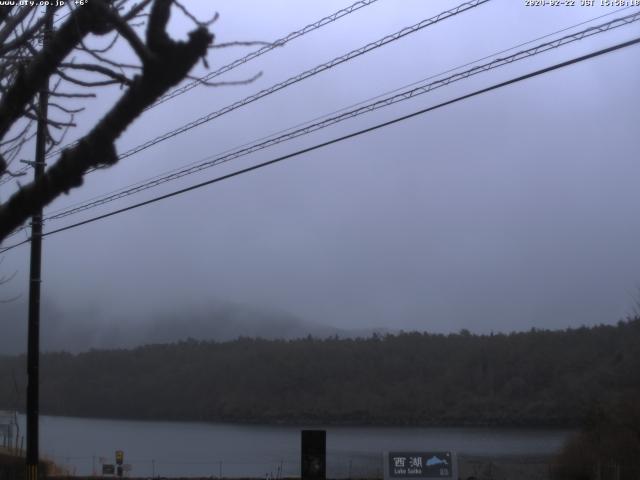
[0,0,215,242]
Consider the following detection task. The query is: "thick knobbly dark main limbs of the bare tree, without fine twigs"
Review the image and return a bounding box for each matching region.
[0,0,213,241]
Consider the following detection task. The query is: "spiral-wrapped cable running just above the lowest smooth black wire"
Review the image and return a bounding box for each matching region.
[38,12,640,225]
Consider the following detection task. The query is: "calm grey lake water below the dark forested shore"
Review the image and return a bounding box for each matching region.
[20,416,572,478]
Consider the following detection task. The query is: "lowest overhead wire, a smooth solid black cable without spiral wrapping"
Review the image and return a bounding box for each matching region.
[0,37,640,253]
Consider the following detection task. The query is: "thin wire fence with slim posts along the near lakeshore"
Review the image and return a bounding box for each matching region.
[11,450,640,480]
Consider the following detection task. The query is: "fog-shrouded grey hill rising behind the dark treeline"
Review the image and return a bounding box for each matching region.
[0,299,389,355]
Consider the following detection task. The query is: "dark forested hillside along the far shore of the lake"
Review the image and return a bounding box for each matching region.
[0,318,640,426]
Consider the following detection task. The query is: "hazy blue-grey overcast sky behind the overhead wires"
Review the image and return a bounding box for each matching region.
[0,0,640,346]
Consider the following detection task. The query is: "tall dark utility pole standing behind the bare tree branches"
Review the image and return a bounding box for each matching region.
[25,7,53,480]
